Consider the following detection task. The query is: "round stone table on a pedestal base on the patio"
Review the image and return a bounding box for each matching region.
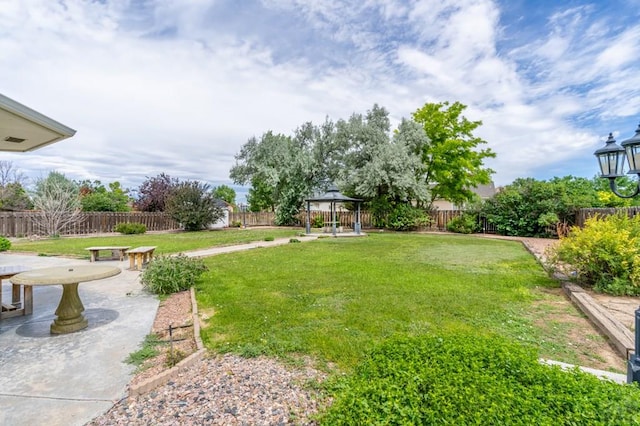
[10,265,121,334]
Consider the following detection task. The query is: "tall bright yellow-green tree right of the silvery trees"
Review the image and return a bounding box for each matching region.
[412,102,495,211]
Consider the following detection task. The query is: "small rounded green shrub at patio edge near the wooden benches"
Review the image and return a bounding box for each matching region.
[140,254,207,294]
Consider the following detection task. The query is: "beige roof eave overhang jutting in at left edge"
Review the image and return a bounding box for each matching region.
[0,94,76,152]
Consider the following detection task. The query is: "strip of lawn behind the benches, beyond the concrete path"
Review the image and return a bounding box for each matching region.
[12,228,301,259]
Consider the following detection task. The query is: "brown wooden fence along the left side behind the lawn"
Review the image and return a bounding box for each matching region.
[0,211,179,237]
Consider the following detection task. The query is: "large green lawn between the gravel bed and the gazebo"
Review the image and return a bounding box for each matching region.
[197,233,577,369]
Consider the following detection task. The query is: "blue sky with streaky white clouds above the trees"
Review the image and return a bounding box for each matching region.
[0,0,640,198]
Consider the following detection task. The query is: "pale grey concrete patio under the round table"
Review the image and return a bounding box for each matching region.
[0,254,158,425]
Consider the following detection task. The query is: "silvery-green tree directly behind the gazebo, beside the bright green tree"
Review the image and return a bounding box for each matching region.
[334,105,428,230]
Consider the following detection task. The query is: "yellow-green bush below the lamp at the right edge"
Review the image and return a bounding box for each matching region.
[549,213,640,296]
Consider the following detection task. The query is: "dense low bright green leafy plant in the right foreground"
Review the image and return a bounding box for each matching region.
[320,334,640,425]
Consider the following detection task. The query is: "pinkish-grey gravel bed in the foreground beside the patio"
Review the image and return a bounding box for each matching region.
[88,355,325,426]
